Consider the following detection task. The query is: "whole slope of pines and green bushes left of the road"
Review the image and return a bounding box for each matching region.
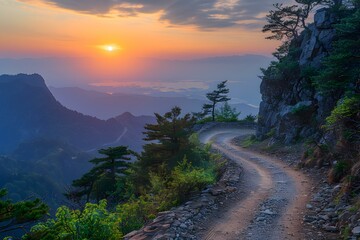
[2,107,219,240]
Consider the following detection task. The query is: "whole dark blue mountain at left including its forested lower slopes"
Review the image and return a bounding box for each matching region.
[0,74,155,214]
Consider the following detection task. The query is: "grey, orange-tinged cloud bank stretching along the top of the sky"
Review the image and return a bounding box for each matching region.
[28,0,286,29]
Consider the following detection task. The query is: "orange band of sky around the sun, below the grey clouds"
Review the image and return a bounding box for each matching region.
[0,0,279,59]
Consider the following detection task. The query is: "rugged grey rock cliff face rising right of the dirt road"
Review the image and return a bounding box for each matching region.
[257,9,337,143]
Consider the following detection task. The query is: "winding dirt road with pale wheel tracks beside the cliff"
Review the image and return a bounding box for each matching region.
[199,128,311,240]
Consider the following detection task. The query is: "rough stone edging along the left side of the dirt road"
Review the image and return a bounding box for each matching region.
[125,155,241,240]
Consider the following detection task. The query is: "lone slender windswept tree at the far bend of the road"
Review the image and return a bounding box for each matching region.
[203,80,230,121]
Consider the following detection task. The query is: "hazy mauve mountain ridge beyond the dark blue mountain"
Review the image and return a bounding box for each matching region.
[50,87,258,119]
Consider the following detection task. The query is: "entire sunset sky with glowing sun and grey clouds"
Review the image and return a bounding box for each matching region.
[0,0,290,102]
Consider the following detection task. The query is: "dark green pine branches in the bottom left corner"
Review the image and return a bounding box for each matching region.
[0,188,49,233]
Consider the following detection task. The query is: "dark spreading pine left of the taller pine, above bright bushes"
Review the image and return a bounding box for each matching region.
[66,146,135,203]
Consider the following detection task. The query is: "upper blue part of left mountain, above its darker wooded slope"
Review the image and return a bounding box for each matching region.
[0,74,150,153]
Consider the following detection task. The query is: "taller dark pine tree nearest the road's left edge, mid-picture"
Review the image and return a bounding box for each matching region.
[135,107,195,186]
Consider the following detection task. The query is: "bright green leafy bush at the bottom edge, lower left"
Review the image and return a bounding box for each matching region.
[24,200,122,240]
